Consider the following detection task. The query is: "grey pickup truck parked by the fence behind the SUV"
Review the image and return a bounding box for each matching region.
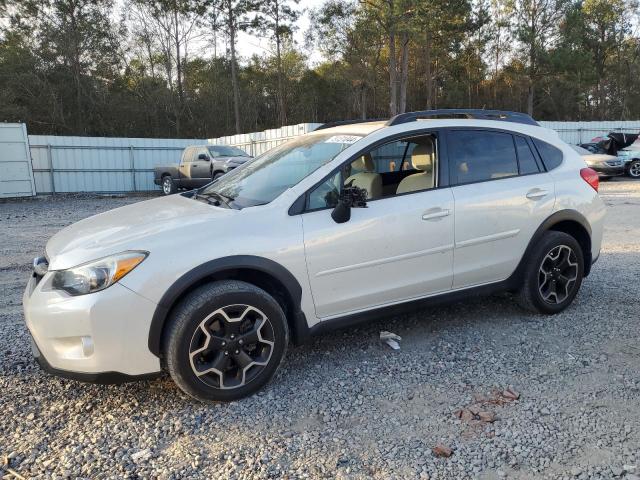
[153,145,251,195]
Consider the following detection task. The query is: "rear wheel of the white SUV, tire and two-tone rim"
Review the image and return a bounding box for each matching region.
[518,231,584,314]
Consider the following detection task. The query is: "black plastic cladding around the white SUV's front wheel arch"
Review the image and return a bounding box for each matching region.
[148,255,308,357]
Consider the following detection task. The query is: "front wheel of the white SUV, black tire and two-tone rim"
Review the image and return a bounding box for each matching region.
[163,280,289,402]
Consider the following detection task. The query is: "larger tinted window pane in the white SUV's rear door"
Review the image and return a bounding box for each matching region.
[448,130,518,184]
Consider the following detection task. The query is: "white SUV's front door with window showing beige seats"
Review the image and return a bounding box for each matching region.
[302,135,454,319]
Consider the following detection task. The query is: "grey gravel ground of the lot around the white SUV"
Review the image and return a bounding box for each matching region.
[0,179,640,480]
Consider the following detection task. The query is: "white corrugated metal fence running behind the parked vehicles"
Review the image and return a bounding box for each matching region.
[0,121,640,196]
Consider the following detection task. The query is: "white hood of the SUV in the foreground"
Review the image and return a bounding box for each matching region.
[46,195,239,270]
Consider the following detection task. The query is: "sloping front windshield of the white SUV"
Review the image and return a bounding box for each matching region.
[198,135,361,208]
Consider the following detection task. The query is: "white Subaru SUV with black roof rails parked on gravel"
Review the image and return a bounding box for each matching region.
[24,110,605,401]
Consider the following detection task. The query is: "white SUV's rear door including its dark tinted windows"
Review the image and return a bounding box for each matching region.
[446,129,555,289]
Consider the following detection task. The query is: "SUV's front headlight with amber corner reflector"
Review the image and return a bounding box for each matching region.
[51,251,149,295]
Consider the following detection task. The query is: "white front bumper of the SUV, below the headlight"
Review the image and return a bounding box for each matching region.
[22,274,160,383]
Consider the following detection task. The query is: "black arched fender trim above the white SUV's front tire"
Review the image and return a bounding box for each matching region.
[149,255,308,357]
